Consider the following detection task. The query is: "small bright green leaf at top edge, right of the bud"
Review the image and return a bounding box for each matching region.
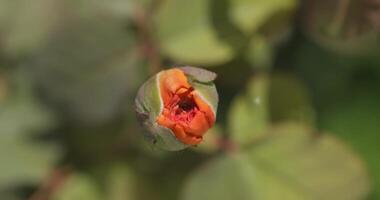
[229,0,298,34]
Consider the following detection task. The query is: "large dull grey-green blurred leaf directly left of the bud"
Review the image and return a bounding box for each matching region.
[28,17,144,125]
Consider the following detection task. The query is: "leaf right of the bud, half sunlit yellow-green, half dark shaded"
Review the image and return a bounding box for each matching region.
[228,74,314,145]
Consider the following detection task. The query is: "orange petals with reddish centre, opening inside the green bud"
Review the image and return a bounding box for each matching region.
[157,70,215,145]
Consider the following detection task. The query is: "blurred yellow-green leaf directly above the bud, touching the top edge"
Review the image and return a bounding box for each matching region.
[154,0,234,65]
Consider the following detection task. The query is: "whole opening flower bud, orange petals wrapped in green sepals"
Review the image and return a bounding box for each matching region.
[135,67,218,151]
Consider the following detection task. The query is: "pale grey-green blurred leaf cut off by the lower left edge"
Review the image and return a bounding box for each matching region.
[0,71,60,187]
